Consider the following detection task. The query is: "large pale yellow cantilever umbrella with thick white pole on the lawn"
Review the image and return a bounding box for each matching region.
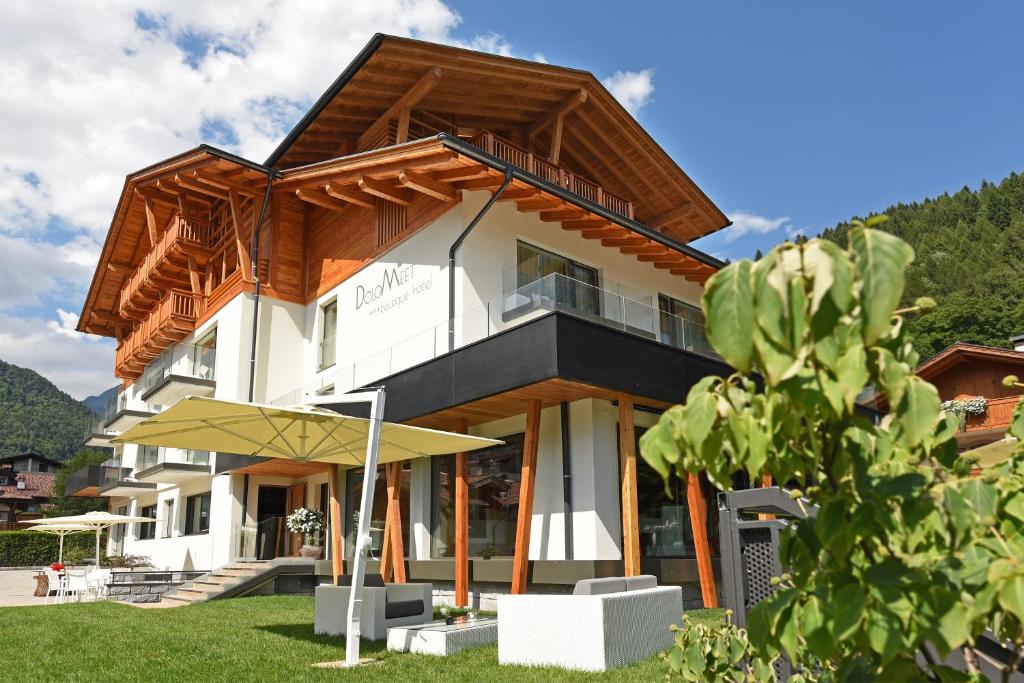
[112,389,502,666]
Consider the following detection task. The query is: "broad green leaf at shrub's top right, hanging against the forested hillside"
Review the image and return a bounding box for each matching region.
[850,227,913,346]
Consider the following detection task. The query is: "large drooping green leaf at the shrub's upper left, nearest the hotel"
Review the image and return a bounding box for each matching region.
[703,260,754,373]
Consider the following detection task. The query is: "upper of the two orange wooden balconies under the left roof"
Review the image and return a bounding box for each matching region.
[119,214,213,319]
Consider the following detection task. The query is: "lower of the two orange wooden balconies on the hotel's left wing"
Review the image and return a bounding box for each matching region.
[114,290,205,380]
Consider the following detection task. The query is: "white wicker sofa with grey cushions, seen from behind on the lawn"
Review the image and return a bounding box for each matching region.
[498,575,683,671]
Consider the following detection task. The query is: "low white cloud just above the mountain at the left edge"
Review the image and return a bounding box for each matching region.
[0,313,116,399]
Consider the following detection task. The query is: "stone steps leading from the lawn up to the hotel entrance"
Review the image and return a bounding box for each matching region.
[161,557,313,607]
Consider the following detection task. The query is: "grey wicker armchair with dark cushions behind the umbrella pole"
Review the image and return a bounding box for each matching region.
[313,573,434,640]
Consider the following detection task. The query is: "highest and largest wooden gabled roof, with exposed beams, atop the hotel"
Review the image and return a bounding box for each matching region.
[266,34,729,242]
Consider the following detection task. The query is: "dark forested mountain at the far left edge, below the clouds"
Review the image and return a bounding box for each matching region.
[0,360,95,460]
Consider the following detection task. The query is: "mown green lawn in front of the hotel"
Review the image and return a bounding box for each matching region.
[0,595,722,683]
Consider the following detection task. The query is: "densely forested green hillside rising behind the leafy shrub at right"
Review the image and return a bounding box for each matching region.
[821,173,1024,358]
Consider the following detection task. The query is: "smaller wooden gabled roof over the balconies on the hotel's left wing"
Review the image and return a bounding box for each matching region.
[77,144,272,337]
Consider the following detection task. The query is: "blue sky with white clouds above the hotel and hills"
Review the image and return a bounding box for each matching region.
[0,0,1024,397]
